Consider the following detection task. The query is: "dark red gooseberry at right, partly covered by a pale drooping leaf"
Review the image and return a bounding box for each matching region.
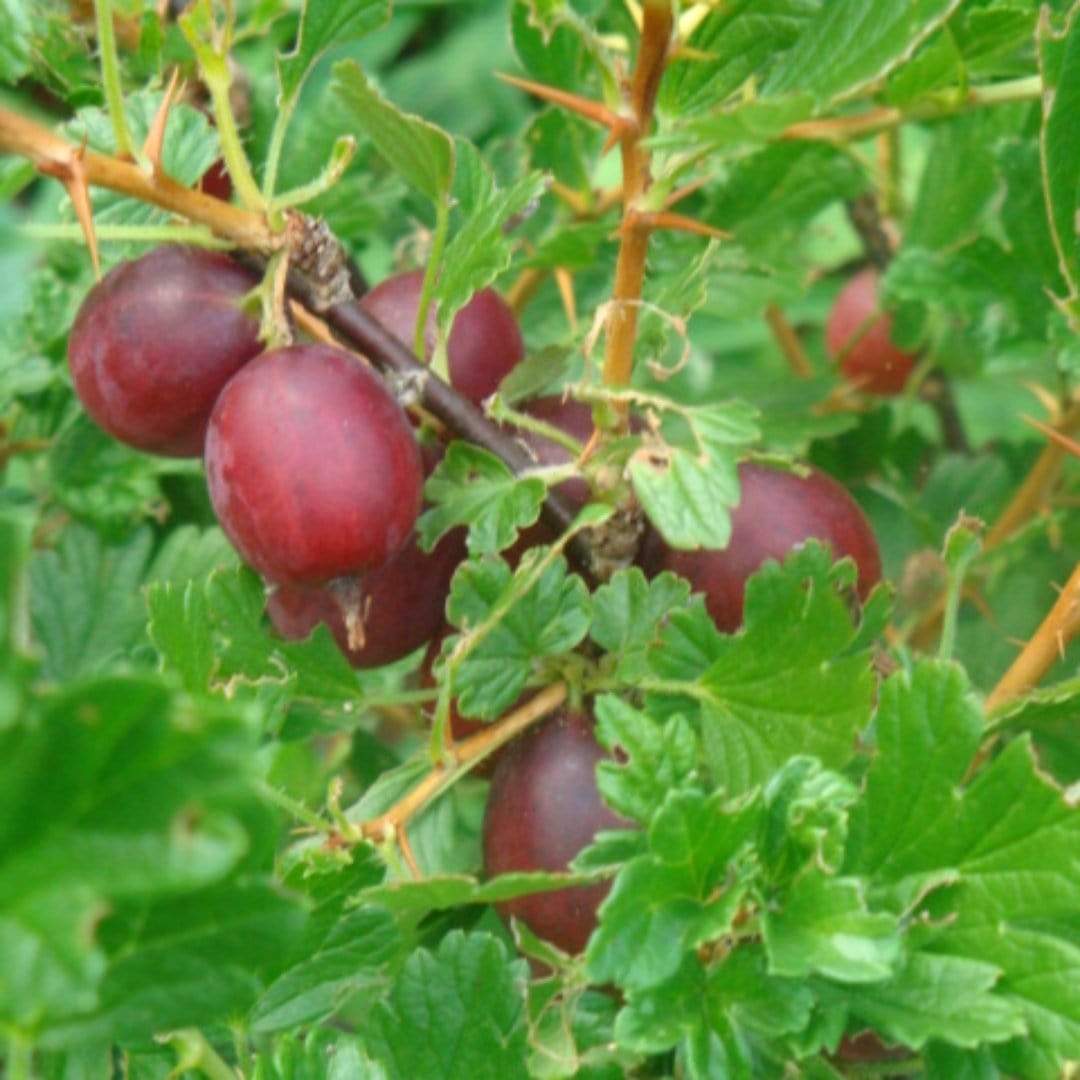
[642,461,881,632]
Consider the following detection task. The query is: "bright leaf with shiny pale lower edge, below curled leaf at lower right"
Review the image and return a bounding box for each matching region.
[761,869,901,983]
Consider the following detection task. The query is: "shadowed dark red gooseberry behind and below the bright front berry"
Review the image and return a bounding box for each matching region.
[267,447,465,667]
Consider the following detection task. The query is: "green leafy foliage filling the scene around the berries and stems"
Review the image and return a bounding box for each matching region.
[0,0,1080,1080]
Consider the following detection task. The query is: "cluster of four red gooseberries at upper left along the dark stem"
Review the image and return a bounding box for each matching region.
[68,246,524,667]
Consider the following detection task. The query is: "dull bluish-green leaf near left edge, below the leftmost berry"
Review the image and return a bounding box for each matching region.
[30,525,152,680]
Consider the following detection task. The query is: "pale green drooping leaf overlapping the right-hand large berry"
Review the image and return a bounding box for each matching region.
[630,402,757,549]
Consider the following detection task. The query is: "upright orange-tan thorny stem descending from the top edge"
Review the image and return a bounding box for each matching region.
[604,0,674,397]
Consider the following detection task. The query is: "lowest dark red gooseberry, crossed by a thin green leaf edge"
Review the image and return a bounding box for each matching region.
[484,710,630,954]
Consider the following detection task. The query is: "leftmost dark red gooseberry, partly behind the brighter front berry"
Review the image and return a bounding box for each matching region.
[68,245,262,457]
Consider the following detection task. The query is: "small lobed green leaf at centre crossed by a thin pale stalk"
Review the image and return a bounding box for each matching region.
[447,556,590,719]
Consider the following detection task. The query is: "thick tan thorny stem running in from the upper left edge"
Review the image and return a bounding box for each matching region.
[0,108,283,254]
